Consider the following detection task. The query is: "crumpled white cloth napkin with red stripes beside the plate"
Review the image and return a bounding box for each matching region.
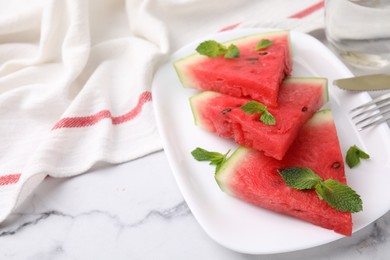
[0,0,323,222]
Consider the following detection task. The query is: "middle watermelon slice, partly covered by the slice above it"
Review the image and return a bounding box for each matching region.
[190,78,328,160]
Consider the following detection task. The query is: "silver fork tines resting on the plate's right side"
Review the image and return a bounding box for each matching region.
[350,92,390,131]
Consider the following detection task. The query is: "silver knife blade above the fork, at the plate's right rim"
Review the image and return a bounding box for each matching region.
[333,74,390,91]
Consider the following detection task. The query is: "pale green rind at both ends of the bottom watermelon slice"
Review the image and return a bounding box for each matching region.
[215,109,333,191]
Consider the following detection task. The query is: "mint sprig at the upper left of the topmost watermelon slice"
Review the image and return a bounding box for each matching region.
[196,40,240,59]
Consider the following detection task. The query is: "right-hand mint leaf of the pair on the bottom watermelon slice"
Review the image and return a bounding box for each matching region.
[315,179,363,213]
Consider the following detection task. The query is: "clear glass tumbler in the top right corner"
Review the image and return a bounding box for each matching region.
[325,0,390,70]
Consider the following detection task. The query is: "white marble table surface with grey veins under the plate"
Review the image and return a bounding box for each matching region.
[0,29,390,260]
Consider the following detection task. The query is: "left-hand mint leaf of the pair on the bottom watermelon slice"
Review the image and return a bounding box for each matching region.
[279,167,322,190]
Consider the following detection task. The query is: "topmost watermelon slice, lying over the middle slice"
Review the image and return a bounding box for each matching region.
[174,31,292,106]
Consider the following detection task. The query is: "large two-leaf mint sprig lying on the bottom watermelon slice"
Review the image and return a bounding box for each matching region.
[278,167,363,213]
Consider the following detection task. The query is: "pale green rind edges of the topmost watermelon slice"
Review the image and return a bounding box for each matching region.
[173,30,292,88]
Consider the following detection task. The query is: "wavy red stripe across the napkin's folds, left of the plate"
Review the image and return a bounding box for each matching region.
[52,91,152,130]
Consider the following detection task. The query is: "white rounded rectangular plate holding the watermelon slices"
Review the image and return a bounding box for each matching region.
[152,29,390,254]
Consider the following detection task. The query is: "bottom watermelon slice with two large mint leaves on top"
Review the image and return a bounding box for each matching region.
[215,110,352,236]
